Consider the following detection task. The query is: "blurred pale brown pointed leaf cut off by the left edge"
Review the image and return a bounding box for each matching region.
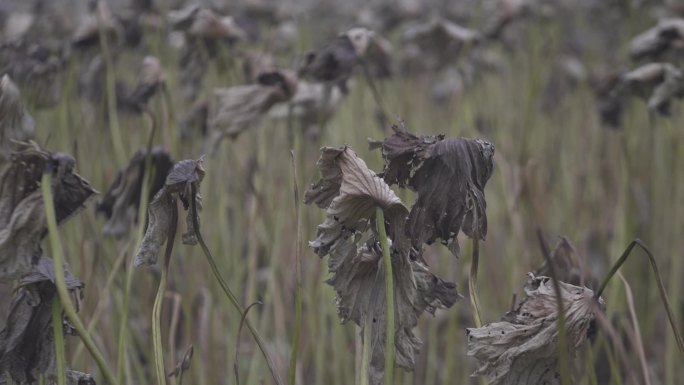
[0,75,35,165]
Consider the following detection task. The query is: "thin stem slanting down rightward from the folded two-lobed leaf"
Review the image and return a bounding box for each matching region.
[190,185,283,385]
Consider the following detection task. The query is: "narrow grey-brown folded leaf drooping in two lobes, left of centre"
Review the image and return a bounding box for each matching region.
[135,157,204,266]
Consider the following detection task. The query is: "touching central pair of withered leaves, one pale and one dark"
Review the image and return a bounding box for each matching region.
[305,127,494,383]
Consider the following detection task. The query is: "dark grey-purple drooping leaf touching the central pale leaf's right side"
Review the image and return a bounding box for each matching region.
[372,126,494,256]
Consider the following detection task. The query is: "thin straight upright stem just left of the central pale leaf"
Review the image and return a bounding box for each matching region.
[287,151,302,385]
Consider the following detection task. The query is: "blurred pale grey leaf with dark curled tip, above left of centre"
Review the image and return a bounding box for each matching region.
[208,71,296,148]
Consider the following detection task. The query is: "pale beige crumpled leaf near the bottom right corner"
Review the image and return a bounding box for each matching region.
[466,273,605,385]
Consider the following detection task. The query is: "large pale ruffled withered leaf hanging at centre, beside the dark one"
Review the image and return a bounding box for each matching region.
[304,147,458,384]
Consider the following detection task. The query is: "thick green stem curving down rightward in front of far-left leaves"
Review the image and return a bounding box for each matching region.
[41,173,119,385]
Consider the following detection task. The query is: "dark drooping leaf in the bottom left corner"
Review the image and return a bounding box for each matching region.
[0,257,84,384]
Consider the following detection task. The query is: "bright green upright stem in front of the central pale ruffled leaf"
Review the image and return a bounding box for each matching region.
[374,207,394,385]
